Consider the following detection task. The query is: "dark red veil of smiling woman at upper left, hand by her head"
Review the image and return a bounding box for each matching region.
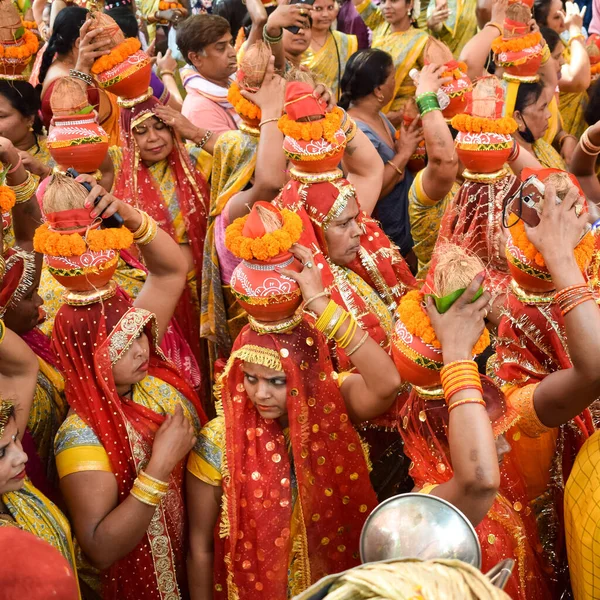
[115,97,210,358]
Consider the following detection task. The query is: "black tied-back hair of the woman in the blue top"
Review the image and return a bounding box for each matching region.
[338,48,394,109]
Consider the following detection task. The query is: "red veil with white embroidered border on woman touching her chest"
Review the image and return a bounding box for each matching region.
[52,296,205,600]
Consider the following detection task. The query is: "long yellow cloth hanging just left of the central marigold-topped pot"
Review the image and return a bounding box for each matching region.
[200,130,259,358]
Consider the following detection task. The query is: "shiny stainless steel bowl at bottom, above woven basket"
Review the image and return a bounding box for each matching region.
[360,493,481,569]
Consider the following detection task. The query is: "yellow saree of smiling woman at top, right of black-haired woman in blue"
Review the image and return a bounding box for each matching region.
[356,0,429,113]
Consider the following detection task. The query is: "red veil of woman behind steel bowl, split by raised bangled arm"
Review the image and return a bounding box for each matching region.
[402,377,550,600]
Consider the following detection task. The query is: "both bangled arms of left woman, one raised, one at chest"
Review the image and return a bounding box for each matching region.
[60,180,196,570]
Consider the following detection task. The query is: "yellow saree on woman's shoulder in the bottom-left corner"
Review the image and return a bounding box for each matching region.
[0,478,81,597]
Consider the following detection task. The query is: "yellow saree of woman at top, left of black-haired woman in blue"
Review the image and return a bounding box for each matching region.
[302,30,358,100]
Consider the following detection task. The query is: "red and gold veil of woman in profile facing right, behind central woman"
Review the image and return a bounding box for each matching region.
[275,174,416,370]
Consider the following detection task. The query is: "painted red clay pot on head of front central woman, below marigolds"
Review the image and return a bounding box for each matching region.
[231,252,303,323]
